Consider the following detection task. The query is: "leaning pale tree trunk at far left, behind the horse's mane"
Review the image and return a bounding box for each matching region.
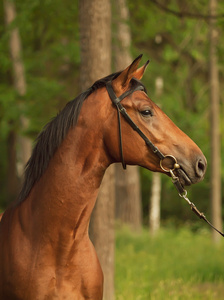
[3,0,32,203]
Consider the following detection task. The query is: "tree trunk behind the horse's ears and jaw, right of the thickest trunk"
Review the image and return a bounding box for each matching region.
[113,0,142,230]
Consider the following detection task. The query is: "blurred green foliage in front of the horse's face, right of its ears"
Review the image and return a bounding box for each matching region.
[128,0,224,221]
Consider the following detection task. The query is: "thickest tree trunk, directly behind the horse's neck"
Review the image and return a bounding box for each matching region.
[79,0,114,300]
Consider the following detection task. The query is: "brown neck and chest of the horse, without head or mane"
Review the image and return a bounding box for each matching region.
[0,92,109,300]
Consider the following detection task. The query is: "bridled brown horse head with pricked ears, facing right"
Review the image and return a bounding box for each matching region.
[104,56,207,185]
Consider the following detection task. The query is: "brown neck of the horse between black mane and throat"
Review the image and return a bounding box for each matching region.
[25,98,110,238]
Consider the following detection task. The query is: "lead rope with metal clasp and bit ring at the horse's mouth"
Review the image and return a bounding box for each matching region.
[160,155,224,237]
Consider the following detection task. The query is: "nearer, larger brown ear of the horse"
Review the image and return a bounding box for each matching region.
[112,54,142,95]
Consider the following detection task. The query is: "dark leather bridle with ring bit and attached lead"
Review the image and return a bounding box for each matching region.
[106,78,224,237]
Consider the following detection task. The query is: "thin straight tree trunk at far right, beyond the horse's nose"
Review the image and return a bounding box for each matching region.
[209,0,222,242]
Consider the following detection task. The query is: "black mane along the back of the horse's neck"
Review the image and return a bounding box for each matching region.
[17,72,145,203]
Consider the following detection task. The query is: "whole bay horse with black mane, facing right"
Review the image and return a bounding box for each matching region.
[0,56,206,300]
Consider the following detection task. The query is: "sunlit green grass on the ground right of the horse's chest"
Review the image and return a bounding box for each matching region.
[115,229,224,300]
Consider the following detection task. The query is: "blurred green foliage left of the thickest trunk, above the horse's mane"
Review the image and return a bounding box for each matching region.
[0,0,80,203]
